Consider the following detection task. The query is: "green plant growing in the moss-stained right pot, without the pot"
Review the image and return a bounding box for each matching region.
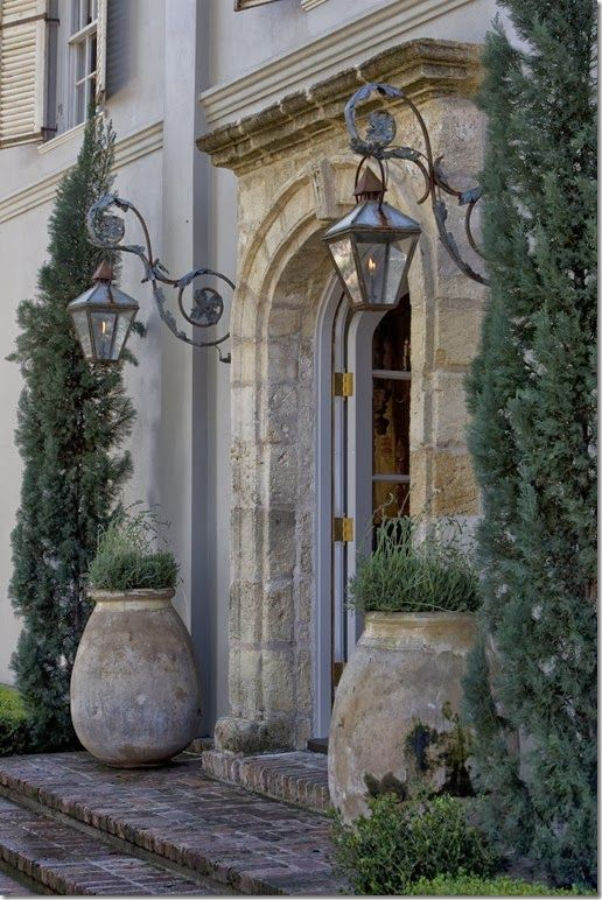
[349,516,480,612]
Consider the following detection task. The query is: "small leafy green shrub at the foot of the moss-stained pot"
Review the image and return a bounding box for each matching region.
[332,795,497,895]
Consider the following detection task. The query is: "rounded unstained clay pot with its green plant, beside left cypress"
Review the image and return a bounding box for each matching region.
[70,504,201,767]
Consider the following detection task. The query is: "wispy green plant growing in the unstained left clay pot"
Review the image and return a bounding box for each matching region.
[88,509,178,591]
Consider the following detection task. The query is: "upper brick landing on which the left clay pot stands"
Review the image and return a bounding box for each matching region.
[0,753,345,896]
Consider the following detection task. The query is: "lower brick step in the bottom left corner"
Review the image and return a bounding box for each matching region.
[0,798,231,897]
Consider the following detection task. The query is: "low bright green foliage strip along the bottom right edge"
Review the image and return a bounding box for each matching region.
[406,874,595,897]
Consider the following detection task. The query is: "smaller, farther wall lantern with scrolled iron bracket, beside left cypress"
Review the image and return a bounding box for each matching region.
[67,194,235,363]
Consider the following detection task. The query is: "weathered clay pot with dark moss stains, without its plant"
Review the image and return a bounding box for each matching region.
[328,613,476,822]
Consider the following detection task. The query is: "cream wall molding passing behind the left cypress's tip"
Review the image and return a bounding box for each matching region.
[0,121,163,225]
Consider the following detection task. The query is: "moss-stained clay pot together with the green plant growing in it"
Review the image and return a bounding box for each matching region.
[328,516,479,821]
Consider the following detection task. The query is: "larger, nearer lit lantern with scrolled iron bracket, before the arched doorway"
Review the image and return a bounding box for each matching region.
[323,83,489,310]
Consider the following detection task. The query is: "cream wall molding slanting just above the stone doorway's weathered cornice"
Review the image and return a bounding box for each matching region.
[200,0,472,129]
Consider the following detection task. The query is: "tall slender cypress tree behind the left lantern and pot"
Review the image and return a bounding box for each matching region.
[10,116,135,749]
